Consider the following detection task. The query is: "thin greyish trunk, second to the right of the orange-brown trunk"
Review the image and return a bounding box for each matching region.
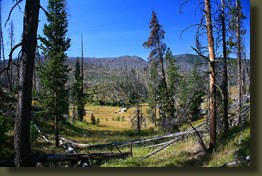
[236,0,242,125]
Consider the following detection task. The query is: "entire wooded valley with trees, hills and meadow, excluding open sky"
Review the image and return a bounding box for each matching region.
[0,0,251,167]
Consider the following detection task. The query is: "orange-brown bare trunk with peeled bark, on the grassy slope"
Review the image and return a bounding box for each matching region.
[205,0,217,151]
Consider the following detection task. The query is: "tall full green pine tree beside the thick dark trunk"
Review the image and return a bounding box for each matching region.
[39,0,70,147]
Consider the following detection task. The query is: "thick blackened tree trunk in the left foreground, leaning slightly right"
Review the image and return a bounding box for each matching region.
[14,0,40,167]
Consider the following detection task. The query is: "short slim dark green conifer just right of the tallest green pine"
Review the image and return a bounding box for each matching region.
[72,58,85,121]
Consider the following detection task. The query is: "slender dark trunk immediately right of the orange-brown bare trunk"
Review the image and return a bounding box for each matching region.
[221,0,228,131]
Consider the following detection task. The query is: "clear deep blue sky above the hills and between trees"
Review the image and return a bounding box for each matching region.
[2,0,250,60]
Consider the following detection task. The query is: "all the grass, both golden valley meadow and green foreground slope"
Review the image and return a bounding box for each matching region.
[0,88,250,167]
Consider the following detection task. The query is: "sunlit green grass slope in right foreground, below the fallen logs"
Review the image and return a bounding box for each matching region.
[102,120,250,167]
